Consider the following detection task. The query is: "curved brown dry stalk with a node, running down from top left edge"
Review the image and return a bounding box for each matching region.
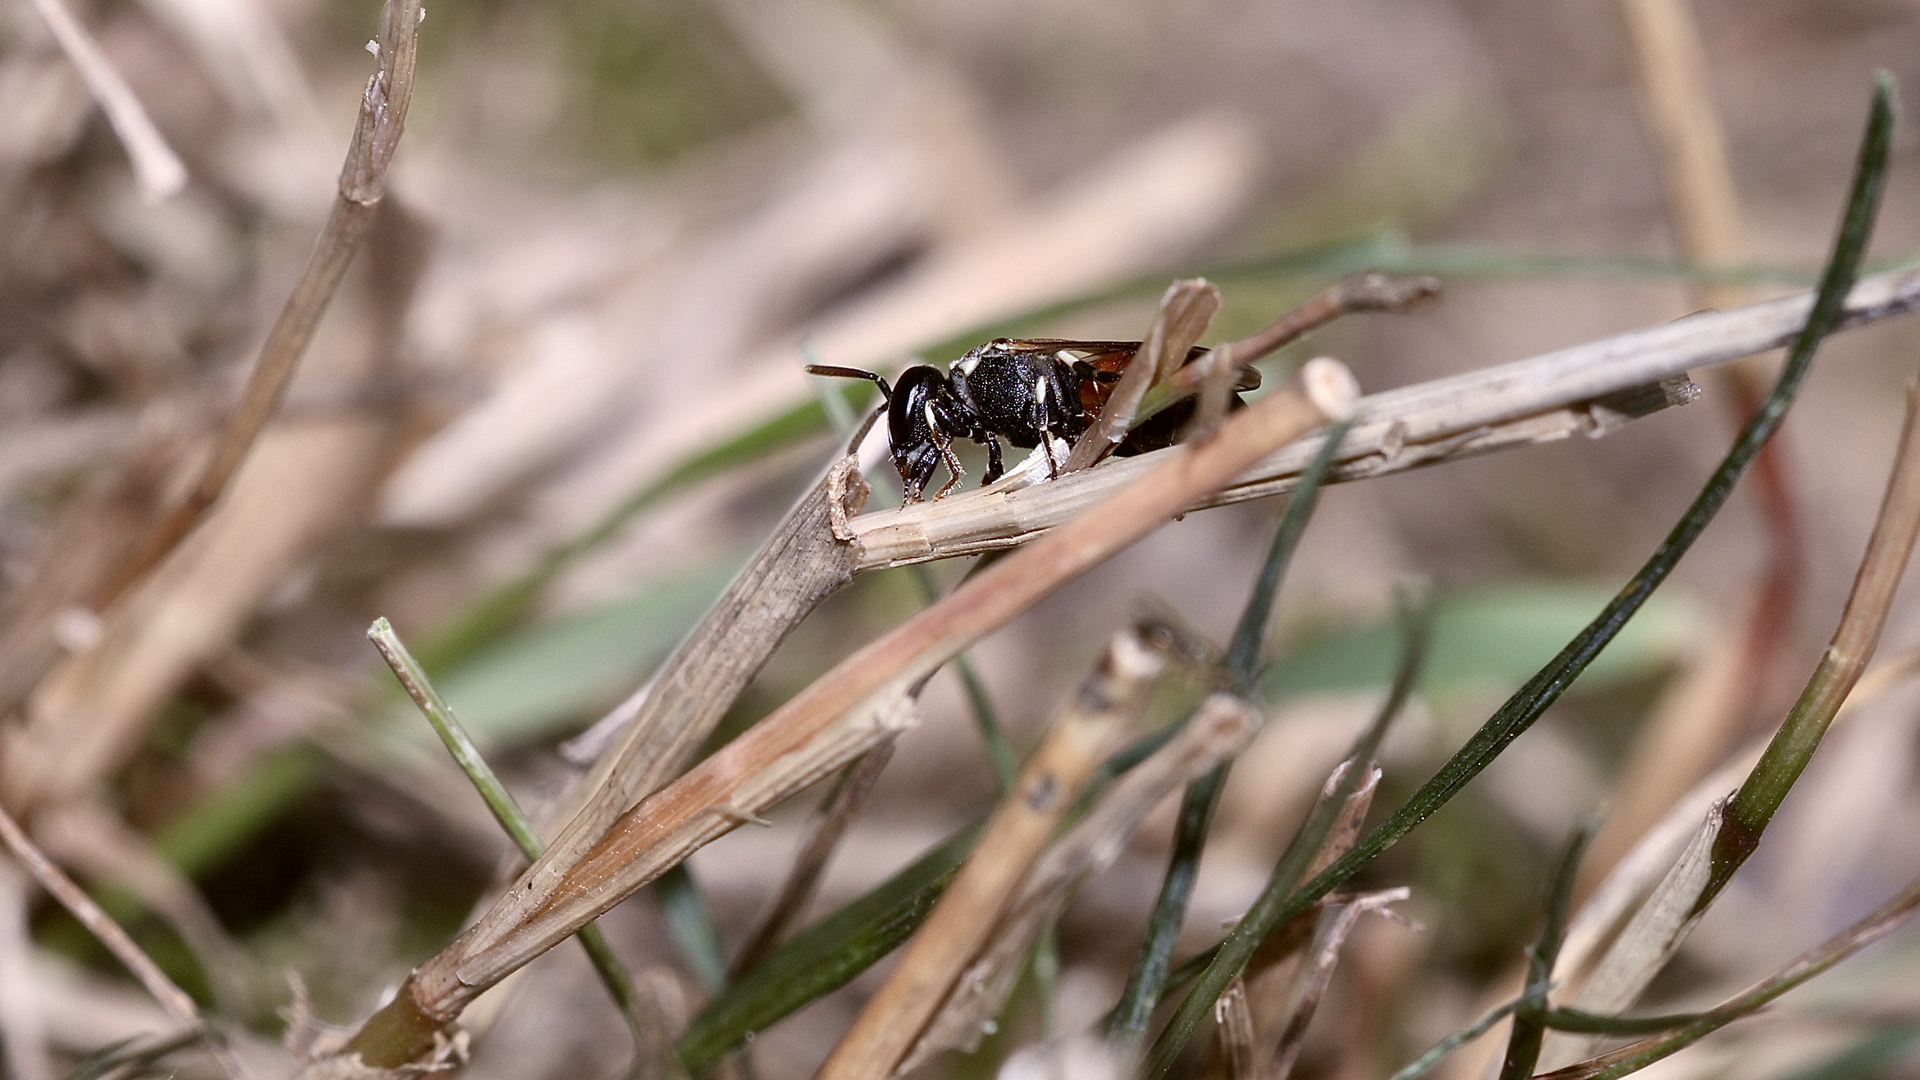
[86,0,422,611]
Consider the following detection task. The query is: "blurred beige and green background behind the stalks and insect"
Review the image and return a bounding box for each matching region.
[0,0,1920,1080]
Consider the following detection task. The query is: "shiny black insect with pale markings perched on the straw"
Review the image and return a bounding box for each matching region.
[806,338,1260,502]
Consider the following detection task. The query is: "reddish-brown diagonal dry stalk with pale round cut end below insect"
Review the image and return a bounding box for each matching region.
[355,353,1352,1045]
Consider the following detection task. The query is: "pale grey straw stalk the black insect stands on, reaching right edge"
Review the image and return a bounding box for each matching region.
[851,271,1920,571]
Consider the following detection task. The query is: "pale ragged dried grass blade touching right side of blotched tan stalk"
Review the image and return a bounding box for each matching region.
[899,694,1260,1072]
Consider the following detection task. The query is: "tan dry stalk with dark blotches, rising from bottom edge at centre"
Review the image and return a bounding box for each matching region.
[816,628,1165,1080]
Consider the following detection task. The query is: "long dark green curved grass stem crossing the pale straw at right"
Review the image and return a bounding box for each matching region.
[1146,77,1893,1078]
